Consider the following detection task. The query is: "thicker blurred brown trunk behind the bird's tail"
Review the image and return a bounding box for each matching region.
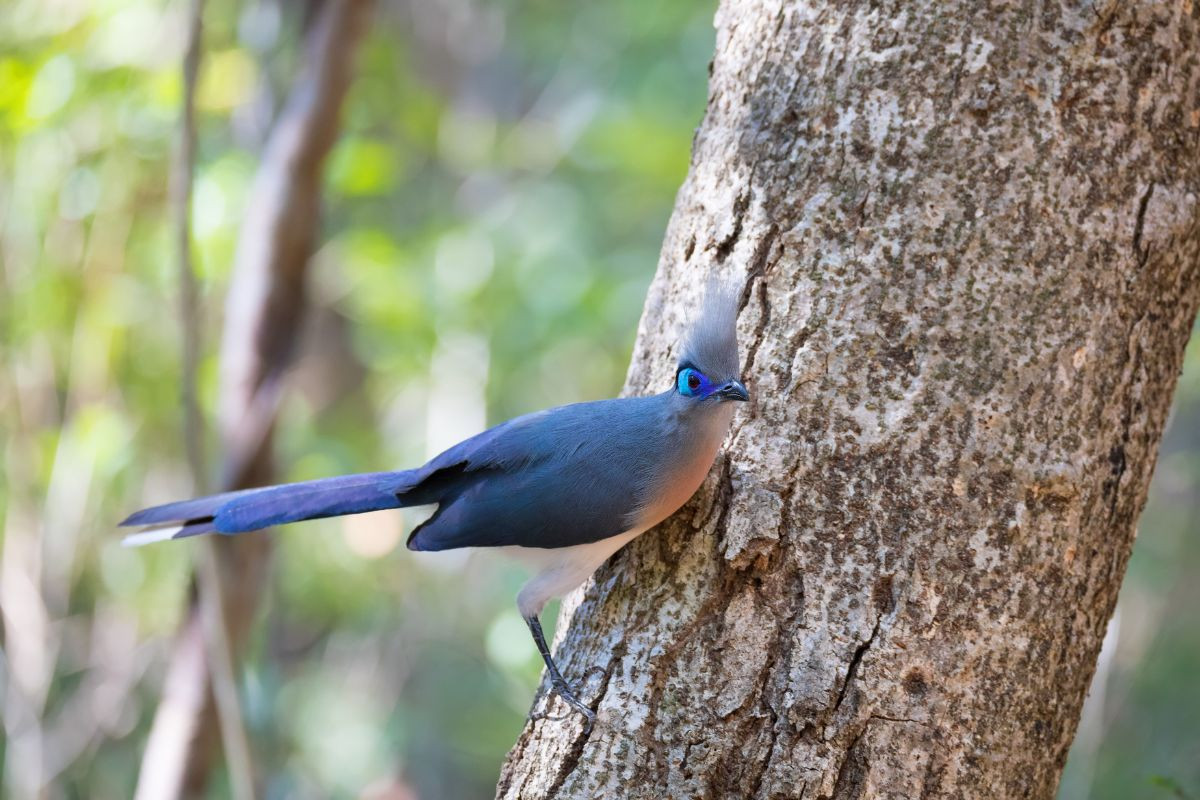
[138,0,371,799]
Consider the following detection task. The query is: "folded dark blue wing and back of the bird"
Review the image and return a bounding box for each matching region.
[406,398,662,551]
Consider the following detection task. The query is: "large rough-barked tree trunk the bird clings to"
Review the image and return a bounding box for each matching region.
[498,0,1200,800]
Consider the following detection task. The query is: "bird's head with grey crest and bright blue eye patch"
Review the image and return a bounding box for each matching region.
[674,285,750,403]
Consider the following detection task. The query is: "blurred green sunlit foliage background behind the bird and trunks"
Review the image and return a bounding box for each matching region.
[0,0,1200,799]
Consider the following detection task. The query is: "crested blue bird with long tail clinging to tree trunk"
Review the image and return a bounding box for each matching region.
[121,288,749,730]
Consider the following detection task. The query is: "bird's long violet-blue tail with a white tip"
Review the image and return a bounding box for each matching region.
[121,470,416,547]
